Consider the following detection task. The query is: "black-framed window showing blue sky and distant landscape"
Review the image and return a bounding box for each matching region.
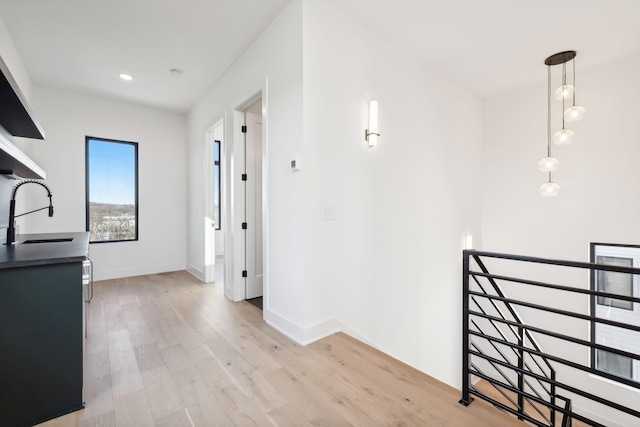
[85,136,138,243]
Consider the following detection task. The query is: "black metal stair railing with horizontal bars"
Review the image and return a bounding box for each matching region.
[460,250,640,427]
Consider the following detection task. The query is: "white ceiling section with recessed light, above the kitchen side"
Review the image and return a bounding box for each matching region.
[0,0,289,113]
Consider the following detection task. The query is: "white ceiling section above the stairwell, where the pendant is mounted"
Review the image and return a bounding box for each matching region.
[325,0,640,97]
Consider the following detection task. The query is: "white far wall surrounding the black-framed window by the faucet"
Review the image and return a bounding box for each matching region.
[18,86,186,280]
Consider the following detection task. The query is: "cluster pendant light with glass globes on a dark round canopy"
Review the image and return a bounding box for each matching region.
[538,50,585,197]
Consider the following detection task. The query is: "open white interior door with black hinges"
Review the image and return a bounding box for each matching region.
[245,112,263,299]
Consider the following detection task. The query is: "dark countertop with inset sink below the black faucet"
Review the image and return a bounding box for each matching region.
[0,231,89,269]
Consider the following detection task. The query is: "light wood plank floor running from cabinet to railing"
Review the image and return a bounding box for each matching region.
[36,272,523,427]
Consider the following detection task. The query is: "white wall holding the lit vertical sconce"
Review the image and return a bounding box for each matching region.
[302,1,481,387]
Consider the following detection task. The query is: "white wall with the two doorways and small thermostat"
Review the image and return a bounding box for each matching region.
[187,0,304,325]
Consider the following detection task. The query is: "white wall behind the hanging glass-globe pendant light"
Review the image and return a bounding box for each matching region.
[480,52,640,425]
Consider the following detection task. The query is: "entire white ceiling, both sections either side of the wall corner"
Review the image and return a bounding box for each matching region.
[0,0,640,112]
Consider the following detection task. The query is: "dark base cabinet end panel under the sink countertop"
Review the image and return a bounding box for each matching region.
[0,261,84,426]
